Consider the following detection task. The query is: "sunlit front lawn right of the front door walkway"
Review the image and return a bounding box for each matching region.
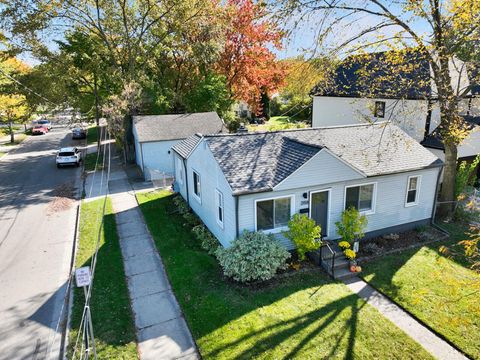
[363,225,480,359]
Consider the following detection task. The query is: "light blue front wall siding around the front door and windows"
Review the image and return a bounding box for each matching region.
[239,168,440,248]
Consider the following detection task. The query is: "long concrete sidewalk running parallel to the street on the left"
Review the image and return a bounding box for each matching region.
[109,162,199,360]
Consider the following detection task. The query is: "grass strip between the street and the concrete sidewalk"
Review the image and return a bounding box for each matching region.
[69,199,138,359]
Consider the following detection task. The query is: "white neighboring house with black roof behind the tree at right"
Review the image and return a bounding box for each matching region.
[311,51,480,159]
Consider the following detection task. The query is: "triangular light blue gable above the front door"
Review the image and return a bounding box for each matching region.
[274,150,364,191]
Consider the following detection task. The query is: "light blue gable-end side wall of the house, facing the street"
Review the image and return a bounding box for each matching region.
[182,140,236,247]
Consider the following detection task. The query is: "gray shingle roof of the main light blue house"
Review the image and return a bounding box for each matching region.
[205,123,442,193]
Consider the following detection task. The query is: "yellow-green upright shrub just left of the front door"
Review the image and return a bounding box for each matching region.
[284,214,321,260]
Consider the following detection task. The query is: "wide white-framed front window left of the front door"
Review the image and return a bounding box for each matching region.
[255,197,292,231]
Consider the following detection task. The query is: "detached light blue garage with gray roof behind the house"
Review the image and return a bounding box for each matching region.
[132,112,226,179]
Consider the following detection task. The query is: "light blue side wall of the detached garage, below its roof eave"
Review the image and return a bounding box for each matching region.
[142,140,180,174]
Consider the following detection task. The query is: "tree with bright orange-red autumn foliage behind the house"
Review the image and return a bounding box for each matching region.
[218,0,285,111]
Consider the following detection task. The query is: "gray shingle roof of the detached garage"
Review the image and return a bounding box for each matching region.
[133,112,225,142]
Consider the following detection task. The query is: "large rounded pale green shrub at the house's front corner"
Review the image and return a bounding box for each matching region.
[215,231,290,282]
